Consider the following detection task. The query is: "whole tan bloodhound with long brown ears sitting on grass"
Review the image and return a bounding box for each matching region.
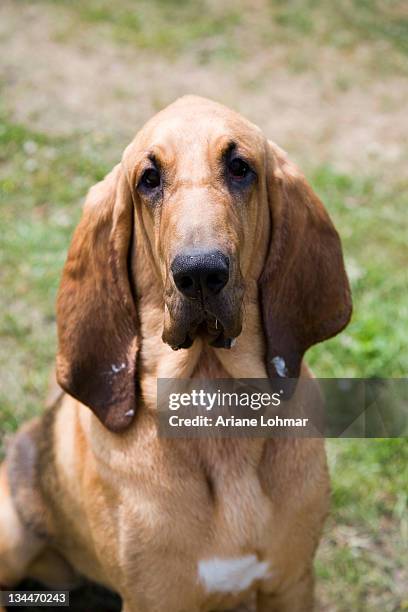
[0,96,351,612]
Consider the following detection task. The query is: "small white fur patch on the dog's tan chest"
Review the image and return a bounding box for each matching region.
[198,555,268,593]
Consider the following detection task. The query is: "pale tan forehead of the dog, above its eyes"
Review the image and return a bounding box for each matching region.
[126,101,264,169]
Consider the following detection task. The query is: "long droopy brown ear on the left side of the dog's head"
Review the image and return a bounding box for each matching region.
[57,165,139,431]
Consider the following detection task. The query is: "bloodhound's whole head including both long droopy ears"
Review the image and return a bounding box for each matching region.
[57,97,351,431]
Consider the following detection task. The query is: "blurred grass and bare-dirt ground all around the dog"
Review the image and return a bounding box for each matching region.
[0,0,408,612]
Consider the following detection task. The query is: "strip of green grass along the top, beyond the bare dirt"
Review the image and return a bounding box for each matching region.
[32,0,408,73]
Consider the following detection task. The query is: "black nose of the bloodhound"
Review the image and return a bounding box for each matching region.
[171,251,229,300]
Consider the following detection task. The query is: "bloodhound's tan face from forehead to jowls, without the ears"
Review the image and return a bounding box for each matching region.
[129,101,269,349]
